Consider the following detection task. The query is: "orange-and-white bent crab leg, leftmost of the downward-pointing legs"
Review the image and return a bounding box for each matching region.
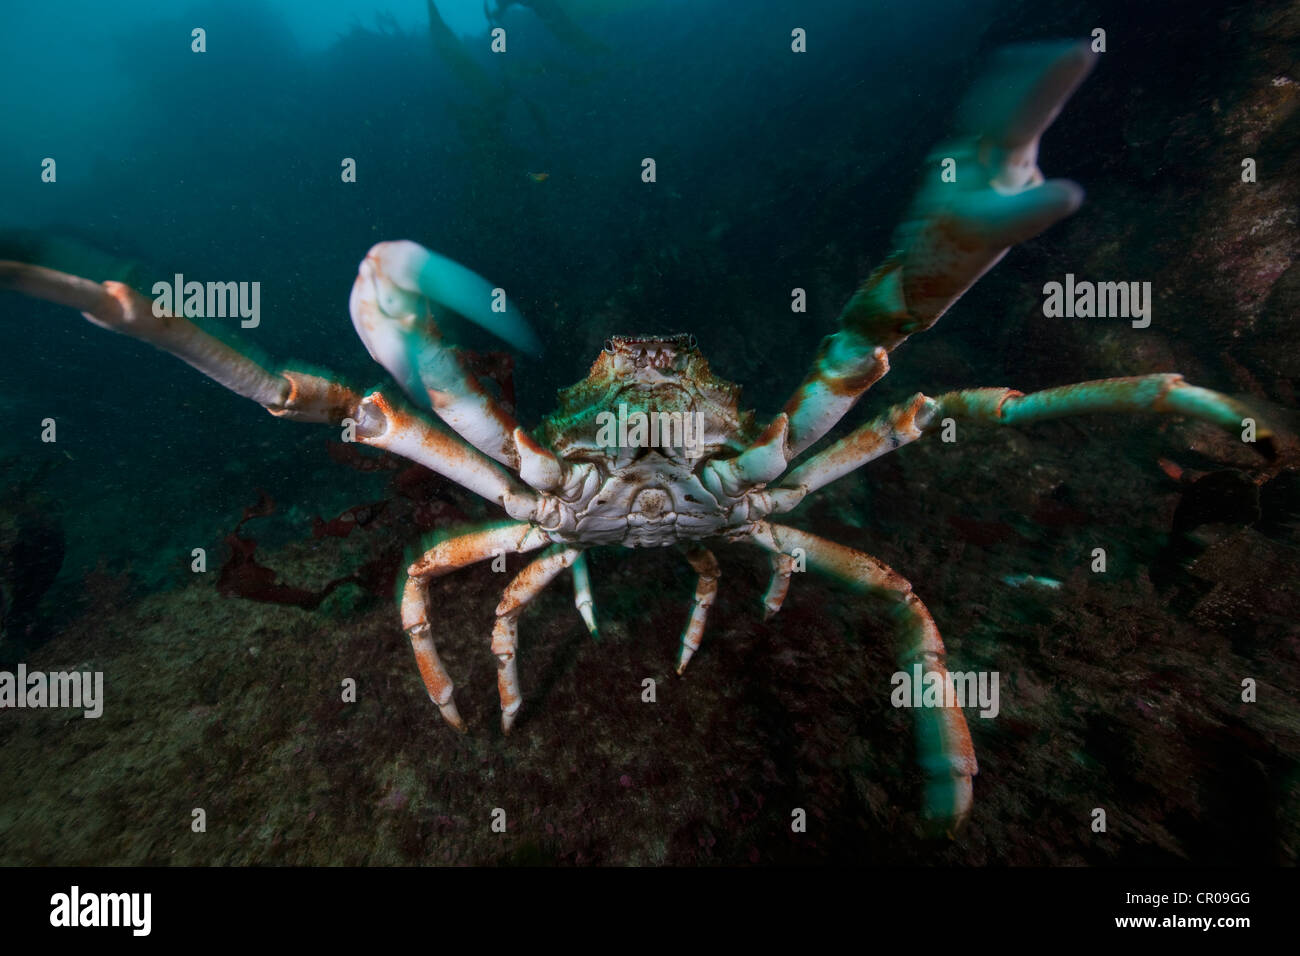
[402,523,549,731]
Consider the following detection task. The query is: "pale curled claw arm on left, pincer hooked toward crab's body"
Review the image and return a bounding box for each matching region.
[348,239,538,468]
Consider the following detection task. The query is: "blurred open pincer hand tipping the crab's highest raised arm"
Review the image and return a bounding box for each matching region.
[896,42,1096,332]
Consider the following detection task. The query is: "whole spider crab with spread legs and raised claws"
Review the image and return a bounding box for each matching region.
[0,43,1263,826]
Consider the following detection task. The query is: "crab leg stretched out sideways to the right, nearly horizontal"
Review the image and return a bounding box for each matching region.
[774,373,1271,512]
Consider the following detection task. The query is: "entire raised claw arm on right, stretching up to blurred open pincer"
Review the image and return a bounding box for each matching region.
[769,43,1096,458]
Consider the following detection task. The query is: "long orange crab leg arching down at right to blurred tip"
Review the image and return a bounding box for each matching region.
[750,522,979,830]
